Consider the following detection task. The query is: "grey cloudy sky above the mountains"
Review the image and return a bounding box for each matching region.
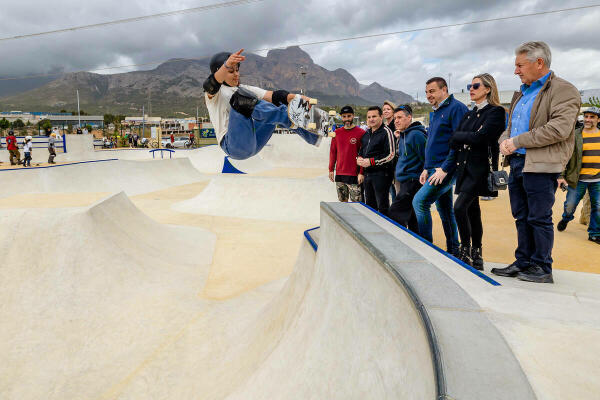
[0,0,600,99]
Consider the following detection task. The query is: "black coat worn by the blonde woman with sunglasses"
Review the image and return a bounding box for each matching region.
[450,104,506,196]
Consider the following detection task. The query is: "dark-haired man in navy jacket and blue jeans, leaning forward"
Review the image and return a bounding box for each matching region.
[413,77,468,255]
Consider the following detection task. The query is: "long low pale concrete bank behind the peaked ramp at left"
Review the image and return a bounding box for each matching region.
[0,158,205,198]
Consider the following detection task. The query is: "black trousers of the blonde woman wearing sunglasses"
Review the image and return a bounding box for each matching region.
[454,192,483,247]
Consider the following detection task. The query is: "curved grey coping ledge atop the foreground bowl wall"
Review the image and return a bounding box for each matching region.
[321,203,536,400]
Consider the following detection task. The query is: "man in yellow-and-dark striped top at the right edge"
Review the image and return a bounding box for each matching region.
[556,107,600,244]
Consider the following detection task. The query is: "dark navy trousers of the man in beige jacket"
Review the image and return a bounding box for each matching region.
[508,156,558,273]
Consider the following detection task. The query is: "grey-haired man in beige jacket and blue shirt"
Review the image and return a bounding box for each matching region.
[492,42,581,283]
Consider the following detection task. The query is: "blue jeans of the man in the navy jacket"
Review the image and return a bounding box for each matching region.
[413,169,458,255]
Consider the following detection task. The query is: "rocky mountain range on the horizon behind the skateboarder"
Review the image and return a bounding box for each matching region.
[0,46,414,116]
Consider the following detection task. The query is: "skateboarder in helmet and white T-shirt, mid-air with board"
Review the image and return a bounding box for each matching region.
[203,49,322,160]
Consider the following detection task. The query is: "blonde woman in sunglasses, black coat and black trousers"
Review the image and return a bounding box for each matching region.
[450,74,506,270]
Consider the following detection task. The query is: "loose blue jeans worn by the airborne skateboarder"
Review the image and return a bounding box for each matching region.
[220,100,320,160]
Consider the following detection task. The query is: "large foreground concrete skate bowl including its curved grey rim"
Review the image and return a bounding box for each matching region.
[0,193,535,400]
